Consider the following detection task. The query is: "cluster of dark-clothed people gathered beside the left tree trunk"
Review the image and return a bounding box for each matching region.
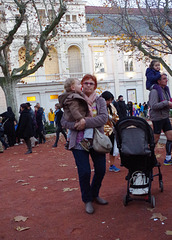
[0,102,46,154]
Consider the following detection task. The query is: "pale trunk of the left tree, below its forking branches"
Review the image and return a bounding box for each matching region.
[1,78,19,119]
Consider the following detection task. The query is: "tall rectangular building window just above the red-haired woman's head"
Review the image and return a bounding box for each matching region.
[94,51,105,73]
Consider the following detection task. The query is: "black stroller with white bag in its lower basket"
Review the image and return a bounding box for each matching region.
[115,117,163,208]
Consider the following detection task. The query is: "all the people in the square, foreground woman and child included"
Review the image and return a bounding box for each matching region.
[0,60,172,214]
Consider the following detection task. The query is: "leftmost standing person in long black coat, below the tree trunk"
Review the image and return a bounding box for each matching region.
[0,107,16,147]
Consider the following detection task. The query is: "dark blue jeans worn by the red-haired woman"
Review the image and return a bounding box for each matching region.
[72,149,106,203]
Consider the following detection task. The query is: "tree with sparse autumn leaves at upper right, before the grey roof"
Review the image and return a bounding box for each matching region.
[87,0,172,76]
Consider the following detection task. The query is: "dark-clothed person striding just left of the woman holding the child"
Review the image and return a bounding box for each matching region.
[53,103,67,147]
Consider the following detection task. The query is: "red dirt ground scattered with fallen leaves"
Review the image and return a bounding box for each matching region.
[0,138,172,240]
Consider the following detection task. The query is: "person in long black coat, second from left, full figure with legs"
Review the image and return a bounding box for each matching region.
[17,103,33,154]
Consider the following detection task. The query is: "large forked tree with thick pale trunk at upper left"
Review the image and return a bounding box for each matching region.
[0,0,66,116]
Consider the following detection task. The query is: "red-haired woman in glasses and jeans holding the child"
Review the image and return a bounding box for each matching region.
[62,74,108,214]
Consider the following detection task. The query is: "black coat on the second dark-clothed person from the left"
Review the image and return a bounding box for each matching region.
[17,109,33,138]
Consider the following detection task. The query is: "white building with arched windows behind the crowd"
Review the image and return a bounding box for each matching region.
[0,0,172,117]
